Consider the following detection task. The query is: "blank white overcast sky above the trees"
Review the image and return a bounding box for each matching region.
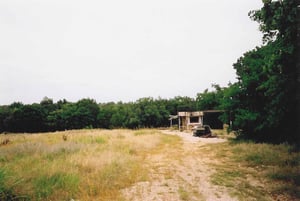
[0,0,262,105]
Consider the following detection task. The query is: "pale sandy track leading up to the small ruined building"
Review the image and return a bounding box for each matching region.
[123,131,236,201]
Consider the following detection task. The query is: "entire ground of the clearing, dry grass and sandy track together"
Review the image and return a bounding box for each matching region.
[0,129,300,201]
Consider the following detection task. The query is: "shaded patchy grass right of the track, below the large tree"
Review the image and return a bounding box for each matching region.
[203,133,300,200]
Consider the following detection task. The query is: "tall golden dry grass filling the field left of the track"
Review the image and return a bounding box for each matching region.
[0,129,175,201]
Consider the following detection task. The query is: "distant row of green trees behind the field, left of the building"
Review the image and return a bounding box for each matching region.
[0,96,216,132]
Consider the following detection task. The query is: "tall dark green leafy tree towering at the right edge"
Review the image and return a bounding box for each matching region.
[223,0,299,142]
